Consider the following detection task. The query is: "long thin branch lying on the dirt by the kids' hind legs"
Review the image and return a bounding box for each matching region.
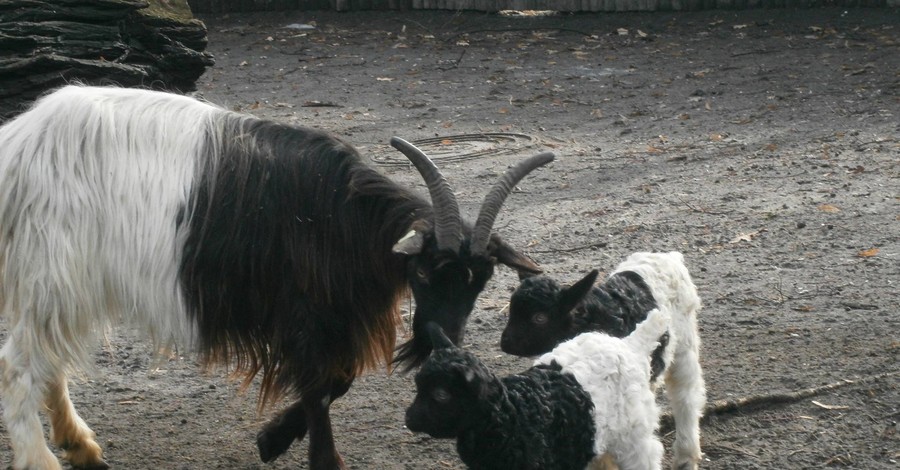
[659,371,900,434]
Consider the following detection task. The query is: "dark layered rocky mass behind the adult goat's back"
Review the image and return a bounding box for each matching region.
[0,0,213,119]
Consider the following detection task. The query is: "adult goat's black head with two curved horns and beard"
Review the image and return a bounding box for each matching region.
[391,137,555,370]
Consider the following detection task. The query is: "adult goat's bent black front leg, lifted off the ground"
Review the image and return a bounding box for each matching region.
[256,378,353,463]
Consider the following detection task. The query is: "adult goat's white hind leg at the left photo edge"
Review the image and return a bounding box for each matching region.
[0,336,62,470]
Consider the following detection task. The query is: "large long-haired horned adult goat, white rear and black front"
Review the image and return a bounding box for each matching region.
[0,86,553,470]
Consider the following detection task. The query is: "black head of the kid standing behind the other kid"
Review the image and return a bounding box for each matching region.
[500,269,599,356]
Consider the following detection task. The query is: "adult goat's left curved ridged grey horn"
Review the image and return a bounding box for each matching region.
[391,137,462,253]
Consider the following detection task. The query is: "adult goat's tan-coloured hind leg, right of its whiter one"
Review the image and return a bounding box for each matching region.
[45,375,109,470]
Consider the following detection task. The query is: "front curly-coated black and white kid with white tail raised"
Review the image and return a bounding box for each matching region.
[406,309,669,470]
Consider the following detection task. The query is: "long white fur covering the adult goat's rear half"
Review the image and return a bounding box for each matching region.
[0,86,225,374]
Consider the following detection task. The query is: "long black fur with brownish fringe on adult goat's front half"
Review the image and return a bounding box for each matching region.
[181,115,432,407]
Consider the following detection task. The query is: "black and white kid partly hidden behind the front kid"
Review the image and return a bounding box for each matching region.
[500,252,706,470]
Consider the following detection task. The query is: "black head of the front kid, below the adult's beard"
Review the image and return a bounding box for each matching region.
[406,323,499,438]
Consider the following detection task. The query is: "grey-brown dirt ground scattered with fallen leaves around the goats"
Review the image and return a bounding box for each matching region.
[0,4,900,469]
